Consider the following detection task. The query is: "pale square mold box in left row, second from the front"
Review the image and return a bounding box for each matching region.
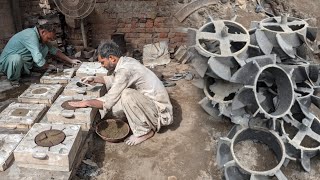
[0,102,47,129]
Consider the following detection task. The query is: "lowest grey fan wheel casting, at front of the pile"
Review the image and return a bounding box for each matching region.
[217,125,288,180]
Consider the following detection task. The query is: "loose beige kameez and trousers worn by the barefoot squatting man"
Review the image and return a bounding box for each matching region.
[98,57,173,137]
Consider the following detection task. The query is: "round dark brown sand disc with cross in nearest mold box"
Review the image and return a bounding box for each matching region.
[34,129,66,147]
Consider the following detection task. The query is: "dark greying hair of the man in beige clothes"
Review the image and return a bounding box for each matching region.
[98,41,121,58]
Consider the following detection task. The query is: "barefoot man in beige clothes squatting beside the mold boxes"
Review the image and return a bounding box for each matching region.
[69,42,173,145]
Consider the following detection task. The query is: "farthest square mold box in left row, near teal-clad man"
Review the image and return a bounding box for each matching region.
[40,68,75,85]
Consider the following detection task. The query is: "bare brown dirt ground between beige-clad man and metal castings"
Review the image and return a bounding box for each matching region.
[73,63,231,180]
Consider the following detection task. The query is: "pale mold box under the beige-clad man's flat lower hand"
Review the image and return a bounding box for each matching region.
[47,95,98,131]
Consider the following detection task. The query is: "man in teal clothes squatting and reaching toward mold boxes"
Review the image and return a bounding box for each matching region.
[0,23,81,81]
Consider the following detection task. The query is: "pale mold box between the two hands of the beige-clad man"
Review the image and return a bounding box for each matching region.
[62,77,106,97]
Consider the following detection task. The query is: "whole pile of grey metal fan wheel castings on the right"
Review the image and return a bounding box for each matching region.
[188,15,320,179]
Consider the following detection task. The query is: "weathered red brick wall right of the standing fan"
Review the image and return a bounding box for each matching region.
[88,0,187,49]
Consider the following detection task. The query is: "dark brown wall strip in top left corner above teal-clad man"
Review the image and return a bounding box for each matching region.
[0,0,15,49]
